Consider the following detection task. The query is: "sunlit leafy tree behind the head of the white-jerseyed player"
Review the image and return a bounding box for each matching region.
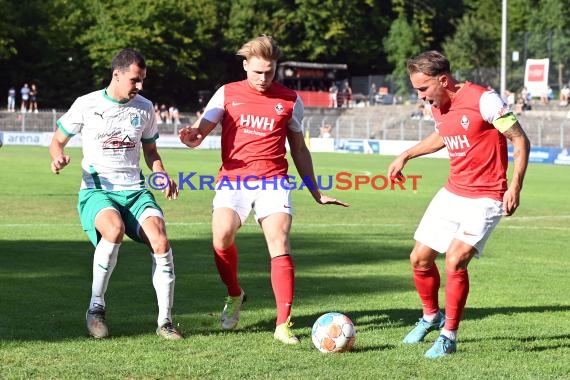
[78,0,220,107]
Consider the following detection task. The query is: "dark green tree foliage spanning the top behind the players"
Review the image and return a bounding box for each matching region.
[0,0,570,109]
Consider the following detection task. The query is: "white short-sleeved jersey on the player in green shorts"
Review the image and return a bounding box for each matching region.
[57,90,158,191]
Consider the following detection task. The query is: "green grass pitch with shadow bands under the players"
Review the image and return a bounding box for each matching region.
[0,146,570,379]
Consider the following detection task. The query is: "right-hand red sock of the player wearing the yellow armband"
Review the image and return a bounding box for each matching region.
[445,269,469,331]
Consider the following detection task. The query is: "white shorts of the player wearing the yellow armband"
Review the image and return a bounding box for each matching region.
[414,188,503,257]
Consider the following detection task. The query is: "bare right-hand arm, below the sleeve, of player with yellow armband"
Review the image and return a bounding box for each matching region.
[503,121,530,216]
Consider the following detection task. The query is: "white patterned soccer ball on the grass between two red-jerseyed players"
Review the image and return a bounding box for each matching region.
[311,312,356,353]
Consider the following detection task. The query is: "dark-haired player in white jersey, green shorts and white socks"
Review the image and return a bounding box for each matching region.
[50,49,183,340]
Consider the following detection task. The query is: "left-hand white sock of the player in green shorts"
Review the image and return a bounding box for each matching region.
[89,238,121,308]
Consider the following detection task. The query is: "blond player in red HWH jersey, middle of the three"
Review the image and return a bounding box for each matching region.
[180,35,348,344]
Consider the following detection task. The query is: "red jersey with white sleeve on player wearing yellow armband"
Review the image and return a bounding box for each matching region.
[432,82,510,201]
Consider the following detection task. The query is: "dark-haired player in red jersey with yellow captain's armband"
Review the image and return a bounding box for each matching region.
[388,51,530,358]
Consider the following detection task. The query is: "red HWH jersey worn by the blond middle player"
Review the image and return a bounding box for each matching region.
[204,80,303,181]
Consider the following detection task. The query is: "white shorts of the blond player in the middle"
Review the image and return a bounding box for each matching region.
[213,181,293,225]
